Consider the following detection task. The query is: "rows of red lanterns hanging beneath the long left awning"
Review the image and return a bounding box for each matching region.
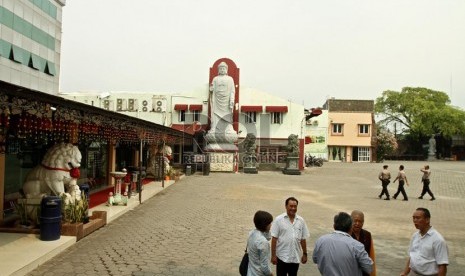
[0,93,183,144]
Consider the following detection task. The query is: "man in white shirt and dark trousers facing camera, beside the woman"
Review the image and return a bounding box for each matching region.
[271,197,310,276]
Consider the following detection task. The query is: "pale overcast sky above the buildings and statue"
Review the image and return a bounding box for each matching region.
[60,0,465,109]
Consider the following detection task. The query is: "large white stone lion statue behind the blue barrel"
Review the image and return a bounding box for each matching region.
[23,143,82,200]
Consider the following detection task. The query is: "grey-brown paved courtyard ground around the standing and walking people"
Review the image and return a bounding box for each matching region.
[29,161,465,276]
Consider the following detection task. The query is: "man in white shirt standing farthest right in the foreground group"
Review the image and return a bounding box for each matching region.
[400,208,449,276]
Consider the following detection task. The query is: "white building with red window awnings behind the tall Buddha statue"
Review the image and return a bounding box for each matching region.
[60,85,304,168]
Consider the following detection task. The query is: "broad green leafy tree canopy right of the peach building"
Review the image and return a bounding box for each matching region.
[375,87,465,141]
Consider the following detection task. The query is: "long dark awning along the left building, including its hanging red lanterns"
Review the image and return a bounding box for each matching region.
[0,81,192,144]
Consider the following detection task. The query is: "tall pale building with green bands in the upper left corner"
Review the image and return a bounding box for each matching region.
[0,0,66,94]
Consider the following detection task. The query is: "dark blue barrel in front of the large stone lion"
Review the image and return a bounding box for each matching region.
[39,196,61,241]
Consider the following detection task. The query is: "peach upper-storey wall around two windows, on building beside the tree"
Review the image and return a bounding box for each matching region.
[328,112,373,147]
